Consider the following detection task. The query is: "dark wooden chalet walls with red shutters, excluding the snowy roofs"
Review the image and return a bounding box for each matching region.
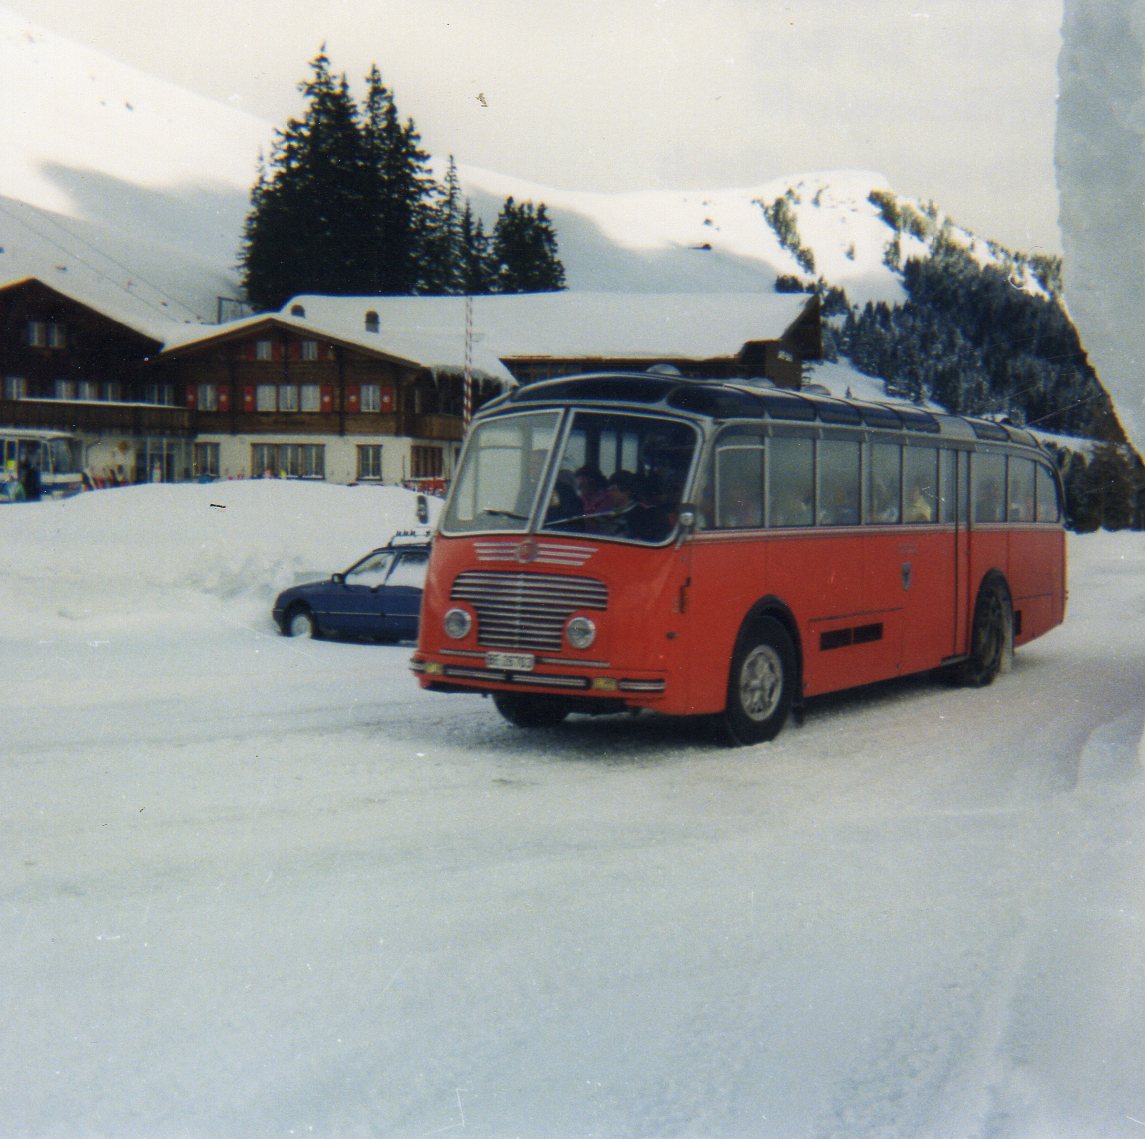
[0,279,821,482]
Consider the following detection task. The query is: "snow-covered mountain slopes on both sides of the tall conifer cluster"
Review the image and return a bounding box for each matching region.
[0,7,1048,339]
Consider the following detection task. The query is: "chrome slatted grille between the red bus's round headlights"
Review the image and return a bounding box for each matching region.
[450,570,608,652]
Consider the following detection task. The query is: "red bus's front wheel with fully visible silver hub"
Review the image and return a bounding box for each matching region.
[721,617,796,746]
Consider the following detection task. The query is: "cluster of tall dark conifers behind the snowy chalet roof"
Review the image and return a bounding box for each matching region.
[239,52,564,309]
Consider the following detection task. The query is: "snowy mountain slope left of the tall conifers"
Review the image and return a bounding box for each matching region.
[0,7,271,331]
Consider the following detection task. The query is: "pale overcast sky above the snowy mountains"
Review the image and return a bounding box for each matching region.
[0,0,1061,253]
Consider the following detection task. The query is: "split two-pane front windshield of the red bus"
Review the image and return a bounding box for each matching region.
[443,411,698,543]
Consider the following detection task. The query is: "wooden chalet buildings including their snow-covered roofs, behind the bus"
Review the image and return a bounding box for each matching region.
[0,279,821,483]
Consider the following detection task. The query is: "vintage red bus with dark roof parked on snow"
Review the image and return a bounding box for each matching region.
[411,373,1066,744]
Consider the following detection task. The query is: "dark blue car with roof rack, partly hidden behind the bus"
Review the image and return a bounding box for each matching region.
[274,538,429,641]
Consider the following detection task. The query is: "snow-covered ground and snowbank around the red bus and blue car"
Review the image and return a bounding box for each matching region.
[0,482,1145,1139]
